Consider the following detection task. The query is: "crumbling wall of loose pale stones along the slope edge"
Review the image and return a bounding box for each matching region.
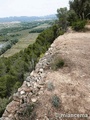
[0,41,55,120]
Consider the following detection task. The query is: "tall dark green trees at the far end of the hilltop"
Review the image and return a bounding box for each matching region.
[57,0,90,31]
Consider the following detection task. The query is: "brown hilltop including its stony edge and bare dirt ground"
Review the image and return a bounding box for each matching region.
[1,27,90,120]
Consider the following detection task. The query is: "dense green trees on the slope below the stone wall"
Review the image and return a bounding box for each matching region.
[0,24,64,116]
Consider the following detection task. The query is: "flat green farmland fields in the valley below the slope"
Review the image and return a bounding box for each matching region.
[0,21,53,57]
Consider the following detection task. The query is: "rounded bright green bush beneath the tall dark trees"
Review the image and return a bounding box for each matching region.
[72,20,86,31]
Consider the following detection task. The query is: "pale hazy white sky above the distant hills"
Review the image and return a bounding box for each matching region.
[0,0,69,17]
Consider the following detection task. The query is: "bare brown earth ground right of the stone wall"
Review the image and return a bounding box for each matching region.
[36,27,90,120]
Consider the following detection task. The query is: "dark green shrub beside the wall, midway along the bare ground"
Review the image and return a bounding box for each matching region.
[51,57,64,70]
